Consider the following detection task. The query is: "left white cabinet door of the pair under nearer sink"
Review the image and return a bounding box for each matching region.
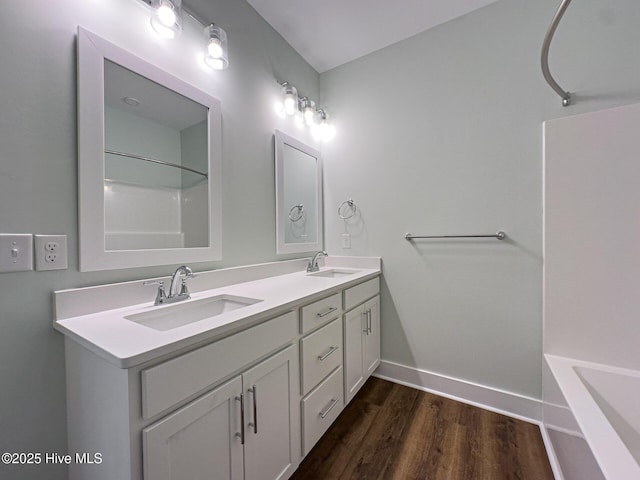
[142,377,244,480]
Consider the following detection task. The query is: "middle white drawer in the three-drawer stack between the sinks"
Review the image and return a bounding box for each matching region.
[300,318,342,395]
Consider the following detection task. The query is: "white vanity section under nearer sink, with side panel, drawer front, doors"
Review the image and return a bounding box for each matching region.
[66,311,301,480]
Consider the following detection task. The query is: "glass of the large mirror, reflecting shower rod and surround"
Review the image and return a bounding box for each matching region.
[104,60,209,250]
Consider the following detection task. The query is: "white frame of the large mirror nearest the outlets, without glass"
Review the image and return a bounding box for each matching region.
[78,27,222,272]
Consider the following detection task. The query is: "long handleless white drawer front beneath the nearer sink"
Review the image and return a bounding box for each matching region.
[141,312,297,419]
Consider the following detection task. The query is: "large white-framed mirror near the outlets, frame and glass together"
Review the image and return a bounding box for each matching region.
[78,28,222,271]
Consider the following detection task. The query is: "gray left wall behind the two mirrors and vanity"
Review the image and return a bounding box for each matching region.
[0,0,319,480]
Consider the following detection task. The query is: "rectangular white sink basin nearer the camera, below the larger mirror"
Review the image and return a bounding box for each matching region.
[124,295,262,331]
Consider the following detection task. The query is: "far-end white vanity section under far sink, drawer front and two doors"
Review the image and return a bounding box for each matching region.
[344,278,380,403]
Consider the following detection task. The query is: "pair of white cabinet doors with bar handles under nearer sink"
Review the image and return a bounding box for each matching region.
[142,345,299,480]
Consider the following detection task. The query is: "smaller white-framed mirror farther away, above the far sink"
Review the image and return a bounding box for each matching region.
[275,130,323,254]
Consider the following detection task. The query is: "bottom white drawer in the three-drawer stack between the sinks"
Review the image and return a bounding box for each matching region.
[302,367,344,455]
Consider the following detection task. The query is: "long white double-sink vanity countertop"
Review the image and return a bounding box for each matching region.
[54,259,381,368]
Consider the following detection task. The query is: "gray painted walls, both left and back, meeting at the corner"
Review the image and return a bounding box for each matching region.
[0,0,640,480]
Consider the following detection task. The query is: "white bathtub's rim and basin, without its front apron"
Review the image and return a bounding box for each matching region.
[545,354,640,480]
